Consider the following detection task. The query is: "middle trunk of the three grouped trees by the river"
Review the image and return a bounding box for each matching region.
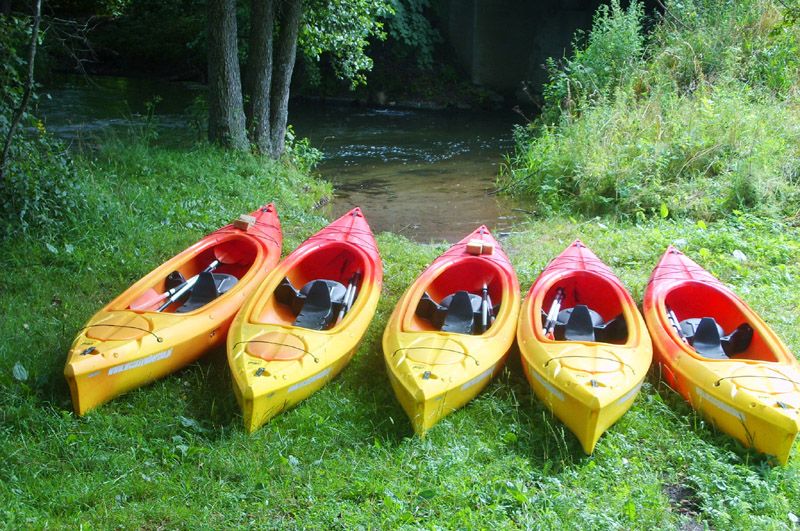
[246,0,275,153]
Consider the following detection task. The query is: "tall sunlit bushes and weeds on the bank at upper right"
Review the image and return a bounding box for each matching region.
[501,0,800,219]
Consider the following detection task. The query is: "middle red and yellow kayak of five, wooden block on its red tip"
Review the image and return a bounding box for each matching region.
[383,226,520,435]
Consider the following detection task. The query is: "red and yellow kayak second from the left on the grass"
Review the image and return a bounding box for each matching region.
[228,208,383,432]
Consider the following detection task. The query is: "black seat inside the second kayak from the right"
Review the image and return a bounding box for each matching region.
[542,304,628,343]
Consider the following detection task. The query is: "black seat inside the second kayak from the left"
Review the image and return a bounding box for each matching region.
[275,278,347,330]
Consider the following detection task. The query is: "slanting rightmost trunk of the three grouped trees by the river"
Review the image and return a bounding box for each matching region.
[270,0,303,159]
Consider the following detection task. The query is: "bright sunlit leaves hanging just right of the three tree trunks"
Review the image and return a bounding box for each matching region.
[299,0,391,85]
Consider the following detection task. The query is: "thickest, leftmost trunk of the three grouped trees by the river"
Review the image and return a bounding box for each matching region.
[208,0,249,150]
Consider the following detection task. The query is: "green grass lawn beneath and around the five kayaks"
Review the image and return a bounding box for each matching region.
[0,141,800,529]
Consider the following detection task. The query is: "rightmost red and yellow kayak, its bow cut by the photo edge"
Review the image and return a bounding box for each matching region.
[644,247,800,463]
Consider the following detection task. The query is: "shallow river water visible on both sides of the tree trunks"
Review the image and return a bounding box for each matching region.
[39,76,515,242]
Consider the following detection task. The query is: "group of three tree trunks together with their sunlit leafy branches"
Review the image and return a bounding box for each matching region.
[208,0,390,158]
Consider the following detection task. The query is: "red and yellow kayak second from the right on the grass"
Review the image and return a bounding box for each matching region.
[517,240,653,454]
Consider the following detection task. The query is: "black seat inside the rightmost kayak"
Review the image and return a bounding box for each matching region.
[678,317,753,360]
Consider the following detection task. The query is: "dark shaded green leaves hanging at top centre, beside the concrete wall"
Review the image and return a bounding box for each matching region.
[386,0,442,70]
